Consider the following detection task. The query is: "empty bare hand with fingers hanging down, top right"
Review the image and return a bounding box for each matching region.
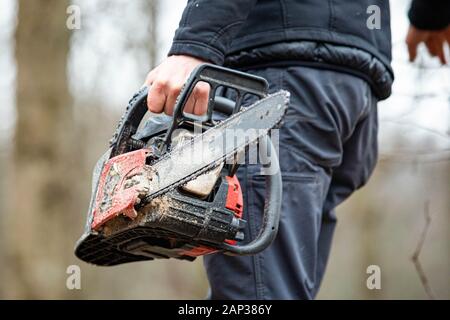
[406,25,450,64]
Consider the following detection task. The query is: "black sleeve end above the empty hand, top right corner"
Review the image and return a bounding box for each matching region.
[408,0,450,30]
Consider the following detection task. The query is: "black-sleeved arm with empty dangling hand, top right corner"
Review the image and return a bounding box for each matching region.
[406,0,450,64]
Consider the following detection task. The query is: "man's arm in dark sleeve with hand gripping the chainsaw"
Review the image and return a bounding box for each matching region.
[145,0,257,115]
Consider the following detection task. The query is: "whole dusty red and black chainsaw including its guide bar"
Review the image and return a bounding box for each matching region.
[75,64,289,266]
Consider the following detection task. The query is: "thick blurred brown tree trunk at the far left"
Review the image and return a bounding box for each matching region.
[2,0,76,298]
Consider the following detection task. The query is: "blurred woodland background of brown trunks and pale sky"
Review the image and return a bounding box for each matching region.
[0,0,450,299]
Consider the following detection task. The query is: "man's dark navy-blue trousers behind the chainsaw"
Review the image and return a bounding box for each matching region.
[204,66,378,299]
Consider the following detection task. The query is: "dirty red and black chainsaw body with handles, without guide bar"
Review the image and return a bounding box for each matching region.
[75,64,288,266]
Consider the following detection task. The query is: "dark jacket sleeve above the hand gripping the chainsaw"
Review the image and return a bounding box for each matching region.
[168,0,257,65]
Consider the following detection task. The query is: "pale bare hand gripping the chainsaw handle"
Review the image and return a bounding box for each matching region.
[145,55,209,115]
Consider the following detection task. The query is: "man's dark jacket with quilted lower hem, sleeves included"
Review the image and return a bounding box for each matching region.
[169,0,450,99]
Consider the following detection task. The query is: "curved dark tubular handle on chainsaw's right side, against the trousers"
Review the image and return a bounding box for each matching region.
[222,135,283,256]
